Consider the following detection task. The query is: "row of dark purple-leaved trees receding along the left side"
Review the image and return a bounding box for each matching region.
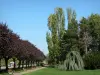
[0,23,45,70]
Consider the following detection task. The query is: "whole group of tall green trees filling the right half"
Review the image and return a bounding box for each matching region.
[46,8,100,69]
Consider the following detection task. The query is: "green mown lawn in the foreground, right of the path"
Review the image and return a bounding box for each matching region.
[24,68,100,75]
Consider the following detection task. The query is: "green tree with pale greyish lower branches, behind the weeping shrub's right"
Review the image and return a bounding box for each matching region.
[79,17,92,54]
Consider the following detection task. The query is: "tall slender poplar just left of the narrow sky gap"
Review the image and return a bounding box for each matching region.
[55,8,65,63]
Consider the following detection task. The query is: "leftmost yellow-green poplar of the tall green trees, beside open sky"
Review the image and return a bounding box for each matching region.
[48,14,59,62]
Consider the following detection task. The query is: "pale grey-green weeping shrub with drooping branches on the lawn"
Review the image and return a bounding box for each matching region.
[58,51,84,70]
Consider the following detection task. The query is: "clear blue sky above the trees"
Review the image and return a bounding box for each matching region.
[0,0,100,54]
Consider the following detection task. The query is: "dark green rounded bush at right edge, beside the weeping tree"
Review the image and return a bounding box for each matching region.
[84,52,100,69]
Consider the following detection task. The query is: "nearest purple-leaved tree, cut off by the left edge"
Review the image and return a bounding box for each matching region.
[0,23,13,71]
